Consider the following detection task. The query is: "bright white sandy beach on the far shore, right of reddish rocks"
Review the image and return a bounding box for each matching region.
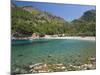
[43,36,96,41]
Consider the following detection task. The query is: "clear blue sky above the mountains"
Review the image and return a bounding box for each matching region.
[13,0,95,22]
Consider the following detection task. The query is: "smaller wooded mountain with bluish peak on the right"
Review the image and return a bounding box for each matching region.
[72,9,96,36]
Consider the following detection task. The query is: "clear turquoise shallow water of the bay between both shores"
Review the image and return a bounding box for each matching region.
[11,39,96,65]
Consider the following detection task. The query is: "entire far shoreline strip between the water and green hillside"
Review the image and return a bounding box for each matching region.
[12,35,96,41]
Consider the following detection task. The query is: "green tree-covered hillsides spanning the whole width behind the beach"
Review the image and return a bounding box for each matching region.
[11,6,96,37]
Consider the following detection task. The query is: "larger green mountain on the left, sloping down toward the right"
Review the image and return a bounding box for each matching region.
[11,6,67,36]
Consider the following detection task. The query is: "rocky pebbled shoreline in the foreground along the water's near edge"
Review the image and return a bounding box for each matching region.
[12,57,96,74]
